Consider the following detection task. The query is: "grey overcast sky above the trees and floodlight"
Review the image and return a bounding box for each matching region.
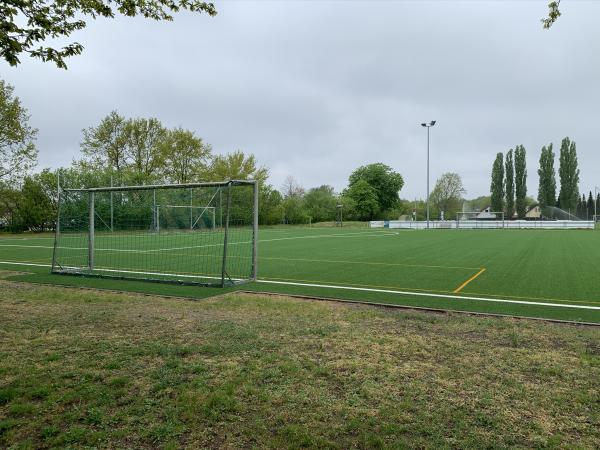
[0,0,600,199]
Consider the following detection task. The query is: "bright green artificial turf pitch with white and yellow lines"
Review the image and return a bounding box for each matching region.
[0,227,600,323]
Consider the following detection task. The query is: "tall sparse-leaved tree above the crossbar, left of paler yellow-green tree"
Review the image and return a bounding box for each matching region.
[162,128,212,183]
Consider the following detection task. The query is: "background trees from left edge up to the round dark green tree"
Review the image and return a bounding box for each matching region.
[0,78,412,231]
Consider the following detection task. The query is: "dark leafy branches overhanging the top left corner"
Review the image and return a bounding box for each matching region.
[0,0,217,69]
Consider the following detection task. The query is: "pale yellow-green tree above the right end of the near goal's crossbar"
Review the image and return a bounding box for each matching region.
[207,150,269,185]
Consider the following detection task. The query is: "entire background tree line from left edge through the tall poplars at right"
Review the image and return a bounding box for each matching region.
[0,76,594,231]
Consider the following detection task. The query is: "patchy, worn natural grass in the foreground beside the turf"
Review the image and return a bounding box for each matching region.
[0,280,600,448]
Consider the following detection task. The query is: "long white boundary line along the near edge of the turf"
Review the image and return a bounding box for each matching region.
[0,261,600,311]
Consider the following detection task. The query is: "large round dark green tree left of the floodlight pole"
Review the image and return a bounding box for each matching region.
[348,163,404,211]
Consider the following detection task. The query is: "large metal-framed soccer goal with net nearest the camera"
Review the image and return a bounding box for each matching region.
[52,181,258,286]
